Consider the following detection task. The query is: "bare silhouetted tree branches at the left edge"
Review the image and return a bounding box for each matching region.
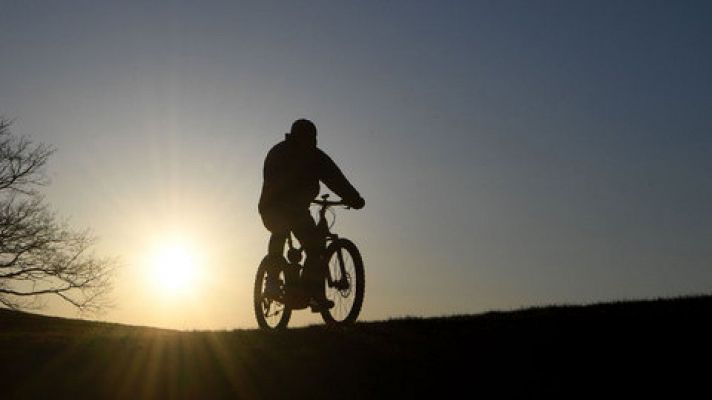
[0,118,113,311]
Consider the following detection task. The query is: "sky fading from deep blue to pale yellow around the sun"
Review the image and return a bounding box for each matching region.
[0,0,712,329]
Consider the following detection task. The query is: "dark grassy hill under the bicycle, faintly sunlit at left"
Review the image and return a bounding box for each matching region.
[0,296,712,399]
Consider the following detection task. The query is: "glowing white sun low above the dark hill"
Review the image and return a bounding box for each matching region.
[152,242,199,294]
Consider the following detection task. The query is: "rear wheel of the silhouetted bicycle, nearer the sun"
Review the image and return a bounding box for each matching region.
[254,256,292,330]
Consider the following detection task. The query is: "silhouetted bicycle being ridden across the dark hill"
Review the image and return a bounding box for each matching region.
[254,194,365,330]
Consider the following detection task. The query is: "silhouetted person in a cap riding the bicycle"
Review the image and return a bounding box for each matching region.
[258,119,366,311]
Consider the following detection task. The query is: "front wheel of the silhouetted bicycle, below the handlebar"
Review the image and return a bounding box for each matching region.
[321,239,366,325]
